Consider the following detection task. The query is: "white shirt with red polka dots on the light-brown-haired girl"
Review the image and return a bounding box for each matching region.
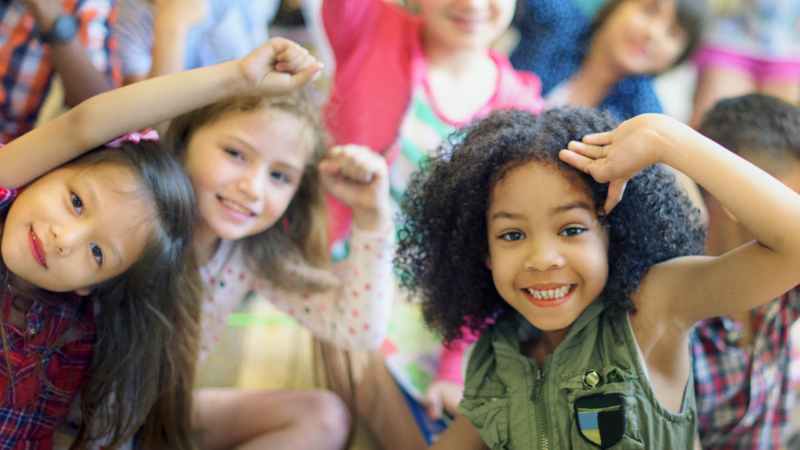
[200,227,394,362]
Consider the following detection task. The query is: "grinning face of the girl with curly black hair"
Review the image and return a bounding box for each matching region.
[486,162,608,331]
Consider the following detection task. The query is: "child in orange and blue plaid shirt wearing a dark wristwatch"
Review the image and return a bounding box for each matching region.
[0,0,122,143]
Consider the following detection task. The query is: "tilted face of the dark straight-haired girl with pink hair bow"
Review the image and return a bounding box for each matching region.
[1,163,152,295]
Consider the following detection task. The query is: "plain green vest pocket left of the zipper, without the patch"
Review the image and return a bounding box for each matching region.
[458,389,510,450]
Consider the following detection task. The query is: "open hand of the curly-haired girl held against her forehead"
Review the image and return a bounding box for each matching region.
[559,114,685,213]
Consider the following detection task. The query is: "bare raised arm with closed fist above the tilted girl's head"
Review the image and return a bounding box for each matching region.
[0,38,322,188]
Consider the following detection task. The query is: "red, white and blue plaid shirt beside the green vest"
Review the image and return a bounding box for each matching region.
[691,286,800,450]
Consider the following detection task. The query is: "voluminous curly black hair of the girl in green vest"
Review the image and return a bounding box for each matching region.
[395,107,705,341]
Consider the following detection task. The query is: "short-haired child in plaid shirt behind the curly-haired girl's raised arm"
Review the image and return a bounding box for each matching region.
[691,94,800,450]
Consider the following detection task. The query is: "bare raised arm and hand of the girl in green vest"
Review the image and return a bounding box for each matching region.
[561,114,800,328]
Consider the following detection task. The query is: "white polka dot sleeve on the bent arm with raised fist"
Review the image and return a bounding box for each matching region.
[253,227,394,350]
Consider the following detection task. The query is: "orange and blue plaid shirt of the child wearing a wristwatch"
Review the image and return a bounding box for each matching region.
[0,0,122,143]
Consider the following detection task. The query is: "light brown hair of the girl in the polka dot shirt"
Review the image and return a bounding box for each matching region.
[166,88,330,291]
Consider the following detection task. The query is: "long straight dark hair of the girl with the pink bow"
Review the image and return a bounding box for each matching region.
[0,141,201,450]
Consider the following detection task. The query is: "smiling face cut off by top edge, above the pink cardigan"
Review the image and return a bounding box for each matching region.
[419,0,516,49]
